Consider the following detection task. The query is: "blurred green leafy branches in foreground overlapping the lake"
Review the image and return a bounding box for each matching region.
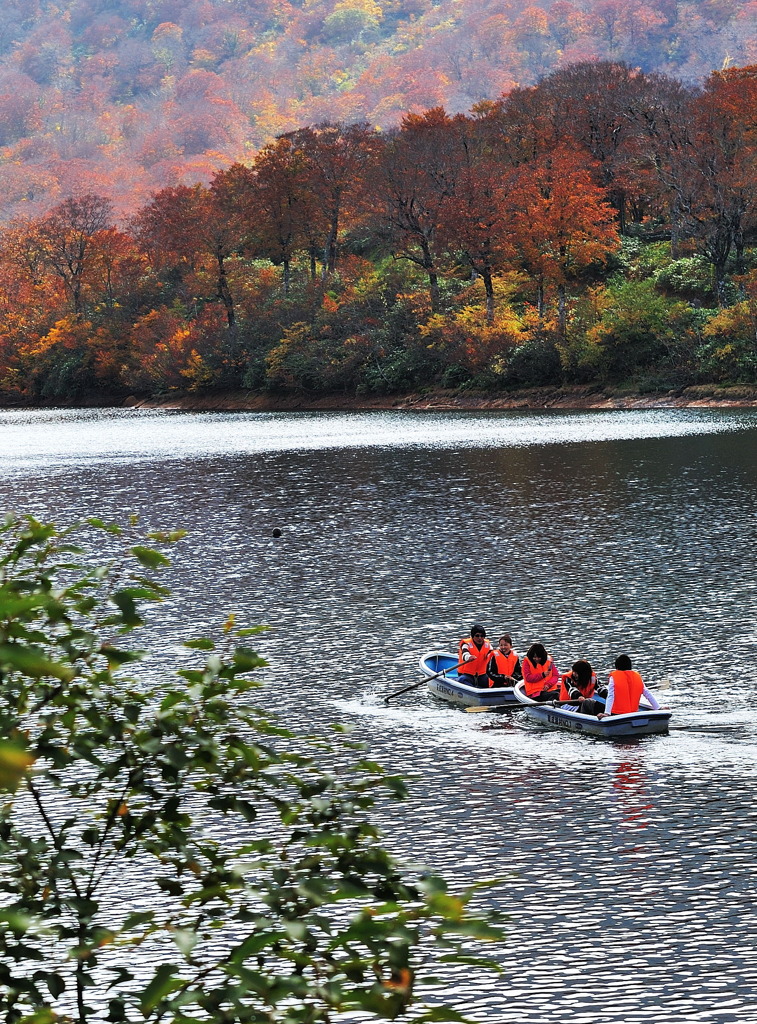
[0,517,500,1024]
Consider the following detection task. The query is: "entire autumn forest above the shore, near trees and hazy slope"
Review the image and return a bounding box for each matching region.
[0,0,757,400]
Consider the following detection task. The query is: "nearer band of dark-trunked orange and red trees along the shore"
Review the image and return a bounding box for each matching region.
[0,61,757,399]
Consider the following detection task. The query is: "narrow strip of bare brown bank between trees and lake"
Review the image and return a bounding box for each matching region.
[0,385,757,413]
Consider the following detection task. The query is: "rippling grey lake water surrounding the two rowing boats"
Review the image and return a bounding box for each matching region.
[0,410,757,1024]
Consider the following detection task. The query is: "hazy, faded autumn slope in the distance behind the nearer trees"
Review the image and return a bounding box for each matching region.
[0,0,757,221]
